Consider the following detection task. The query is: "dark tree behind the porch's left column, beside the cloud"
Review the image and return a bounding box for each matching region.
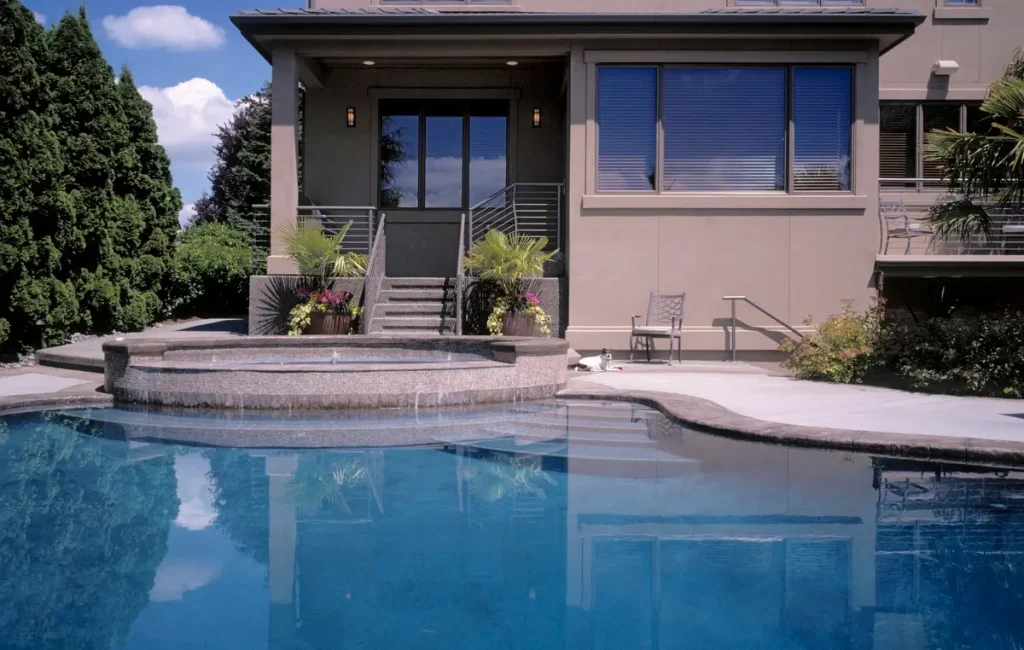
[194,83,271,231]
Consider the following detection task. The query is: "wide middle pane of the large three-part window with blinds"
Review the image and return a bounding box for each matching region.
[662,68,785,191]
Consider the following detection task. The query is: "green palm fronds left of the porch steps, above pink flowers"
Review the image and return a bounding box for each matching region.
[279,217,369,287]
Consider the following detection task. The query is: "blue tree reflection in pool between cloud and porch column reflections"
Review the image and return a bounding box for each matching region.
[205,449,270,566]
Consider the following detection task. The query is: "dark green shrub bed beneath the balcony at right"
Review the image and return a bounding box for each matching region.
[876,310,1024,397]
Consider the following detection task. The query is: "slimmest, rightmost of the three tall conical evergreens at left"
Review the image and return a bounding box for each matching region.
[116,68,181,317]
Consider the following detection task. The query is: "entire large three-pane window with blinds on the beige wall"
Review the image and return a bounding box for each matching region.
[597,66,853,192]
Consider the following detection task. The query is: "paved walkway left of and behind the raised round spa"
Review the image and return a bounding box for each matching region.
[36,318,248,373]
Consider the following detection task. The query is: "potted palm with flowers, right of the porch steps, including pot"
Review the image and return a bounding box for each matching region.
[465,230,557,336]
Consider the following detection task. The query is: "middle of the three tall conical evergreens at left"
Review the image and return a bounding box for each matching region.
[47,7,151,332]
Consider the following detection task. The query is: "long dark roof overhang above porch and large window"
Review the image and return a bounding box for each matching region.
[231,7,925,60]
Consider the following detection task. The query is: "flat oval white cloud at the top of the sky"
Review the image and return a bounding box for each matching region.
[103,4,224,51]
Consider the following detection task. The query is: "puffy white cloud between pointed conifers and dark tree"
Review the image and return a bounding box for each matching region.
[138,77,234,169]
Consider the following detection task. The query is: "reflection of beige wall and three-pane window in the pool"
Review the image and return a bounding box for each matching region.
[567,405,874,648]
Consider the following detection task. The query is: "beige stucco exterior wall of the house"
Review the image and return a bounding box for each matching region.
[271,0,1024,356]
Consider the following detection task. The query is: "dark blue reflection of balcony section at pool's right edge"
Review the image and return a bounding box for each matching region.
[874,459,1024,648]
